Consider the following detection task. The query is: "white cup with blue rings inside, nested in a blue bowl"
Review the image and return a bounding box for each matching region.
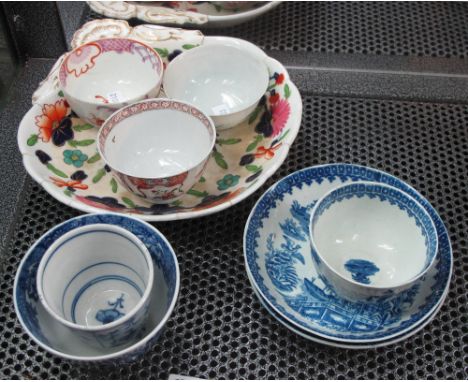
[37,224,154,348]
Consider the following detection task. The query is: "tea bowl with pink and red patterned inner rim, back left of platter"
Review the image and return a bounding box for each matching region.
[59,38,163,126]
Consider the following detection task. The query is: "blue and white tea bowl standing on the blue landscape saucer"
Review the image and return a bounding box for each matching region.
[309,182,438,301]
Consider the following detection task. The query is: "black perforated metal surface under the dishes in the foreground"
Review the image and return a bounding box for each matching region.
[0,96,468,379]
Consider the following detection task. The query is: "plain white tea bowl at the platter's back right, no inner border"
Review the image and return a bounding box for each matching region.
[163,44,269,129]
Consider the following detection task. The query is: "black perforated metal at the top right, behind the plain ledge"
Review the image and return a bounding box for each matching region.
[84,1,468,58]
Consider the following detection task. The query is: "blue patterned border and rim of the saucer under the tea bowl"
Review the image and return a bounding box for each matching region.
[244,163,453,343]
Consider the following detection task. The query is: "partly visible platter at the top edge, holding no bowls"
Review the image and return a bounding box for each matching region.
[88,1,280,27]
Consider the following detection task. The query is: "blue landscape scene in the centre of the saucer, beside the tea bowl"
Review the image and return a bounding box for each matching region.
[265,202,419,332]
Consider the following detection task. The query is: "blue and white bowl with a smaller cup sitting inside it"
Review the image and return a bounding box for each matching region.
[13,214,180,362]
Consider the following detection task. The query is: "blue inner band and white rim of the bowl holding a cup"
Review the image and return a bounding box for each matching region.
[13,213,180,362]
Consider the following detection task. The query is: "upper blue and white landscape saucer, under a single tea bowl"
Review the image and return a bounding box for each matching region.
[244,164,453,343]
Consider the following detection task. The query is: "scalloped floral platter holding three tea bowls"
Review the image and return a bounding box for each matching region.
[18,20,302,221]
